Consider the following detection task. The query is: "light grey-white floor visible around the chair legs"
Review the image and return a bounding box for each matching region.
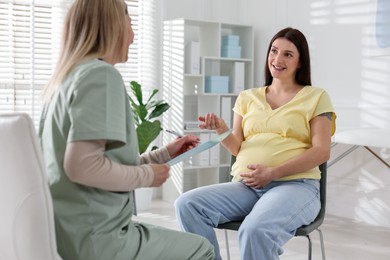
[134,199,390,260]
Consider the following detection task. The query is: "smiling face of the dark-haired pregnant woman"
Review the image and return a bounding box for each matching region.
[268,38,299,79]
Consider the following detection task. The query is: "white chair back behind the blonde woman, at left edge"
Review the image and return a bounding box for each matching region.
[0,113,61,260]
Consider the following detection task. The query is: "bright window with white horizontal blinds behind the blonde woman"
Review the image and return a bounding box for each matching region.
[0,0,158,126]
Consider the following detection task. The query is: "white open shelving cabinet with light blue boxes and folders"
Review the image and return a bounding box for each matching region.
[162,19,254,200]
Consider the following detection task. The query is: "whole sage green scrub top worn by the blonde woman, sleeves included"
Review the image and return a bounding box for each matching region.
[39,60,140,260]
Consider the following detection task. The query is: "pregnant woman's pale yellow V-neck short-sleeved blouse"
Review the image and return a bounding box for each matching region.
[231,86,336,181]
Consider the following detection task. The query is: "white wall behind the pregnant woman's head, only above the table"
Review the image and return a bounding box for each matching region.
[162,0,390,129]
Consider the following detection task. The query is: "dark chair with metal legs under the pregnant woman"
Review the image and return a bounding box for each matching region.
[217,162,327,260]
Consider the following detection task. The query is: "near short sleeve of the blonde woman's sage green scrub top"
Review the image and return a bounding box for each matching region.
[68,65,127,143]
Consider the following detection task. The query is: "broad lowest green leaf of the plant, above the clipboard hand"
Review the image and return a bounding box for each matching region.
[136,120,161,154]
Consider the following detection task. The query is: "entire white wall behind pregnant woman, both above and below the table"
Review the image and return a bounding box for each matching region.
[162,0,390,227]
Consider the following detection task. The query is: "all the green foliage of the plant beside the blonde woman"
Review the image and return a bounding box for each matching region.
[128,81,170,154]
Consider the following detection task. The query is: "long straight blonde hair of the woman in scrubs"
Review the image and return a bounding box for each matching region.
[43,0,127,102]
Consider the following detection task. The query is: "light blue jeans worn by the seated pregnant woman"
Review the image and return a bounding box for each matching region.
[175,179,321,260]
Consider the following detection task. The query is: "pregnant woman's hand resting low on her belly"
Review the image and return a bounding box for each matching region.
[240,164,274,189]
